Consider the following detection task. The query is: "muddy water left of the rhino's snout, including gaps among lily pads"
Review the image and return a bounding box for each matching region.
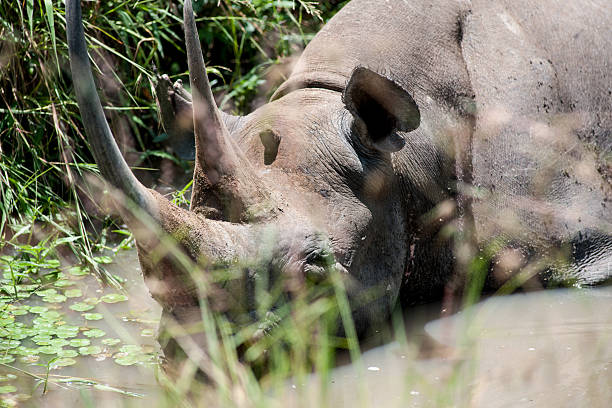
[10,250,161,407]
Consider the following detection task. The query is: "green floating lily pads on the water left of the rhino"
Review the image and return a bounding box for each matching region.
[0,263,157,404]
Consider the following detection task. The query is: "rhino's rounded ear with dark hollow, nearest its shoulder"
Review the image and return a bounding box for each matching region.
[342,67,421,152]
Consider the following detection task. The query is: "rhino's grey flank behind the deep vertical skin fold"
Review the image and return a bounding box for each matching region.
[462,0,612,262]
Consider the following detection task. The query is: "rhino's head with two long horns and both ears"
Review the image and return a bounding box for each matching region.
[66,0,420,329]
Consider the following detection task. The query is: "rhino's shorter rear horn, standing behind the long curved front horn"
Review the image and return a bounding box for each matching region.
[183,0,273,221]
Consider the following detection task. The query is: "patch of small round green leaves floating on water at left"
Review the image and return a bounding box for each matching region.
[0,255,158,405]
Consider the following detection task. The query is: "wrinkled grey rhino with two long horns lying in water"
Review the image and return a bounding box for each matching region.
[67,0,612,340]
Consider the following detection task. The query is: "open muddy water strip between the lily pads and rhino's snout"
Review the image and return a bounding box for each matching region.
[43,250,161,408]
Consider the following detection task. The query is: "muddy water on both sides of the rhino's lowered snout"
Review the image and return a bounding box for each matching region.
[7,251,612,407]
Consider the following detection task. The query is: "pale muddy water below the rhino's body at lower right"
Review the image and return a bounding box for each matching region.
[292,287,612,408]
